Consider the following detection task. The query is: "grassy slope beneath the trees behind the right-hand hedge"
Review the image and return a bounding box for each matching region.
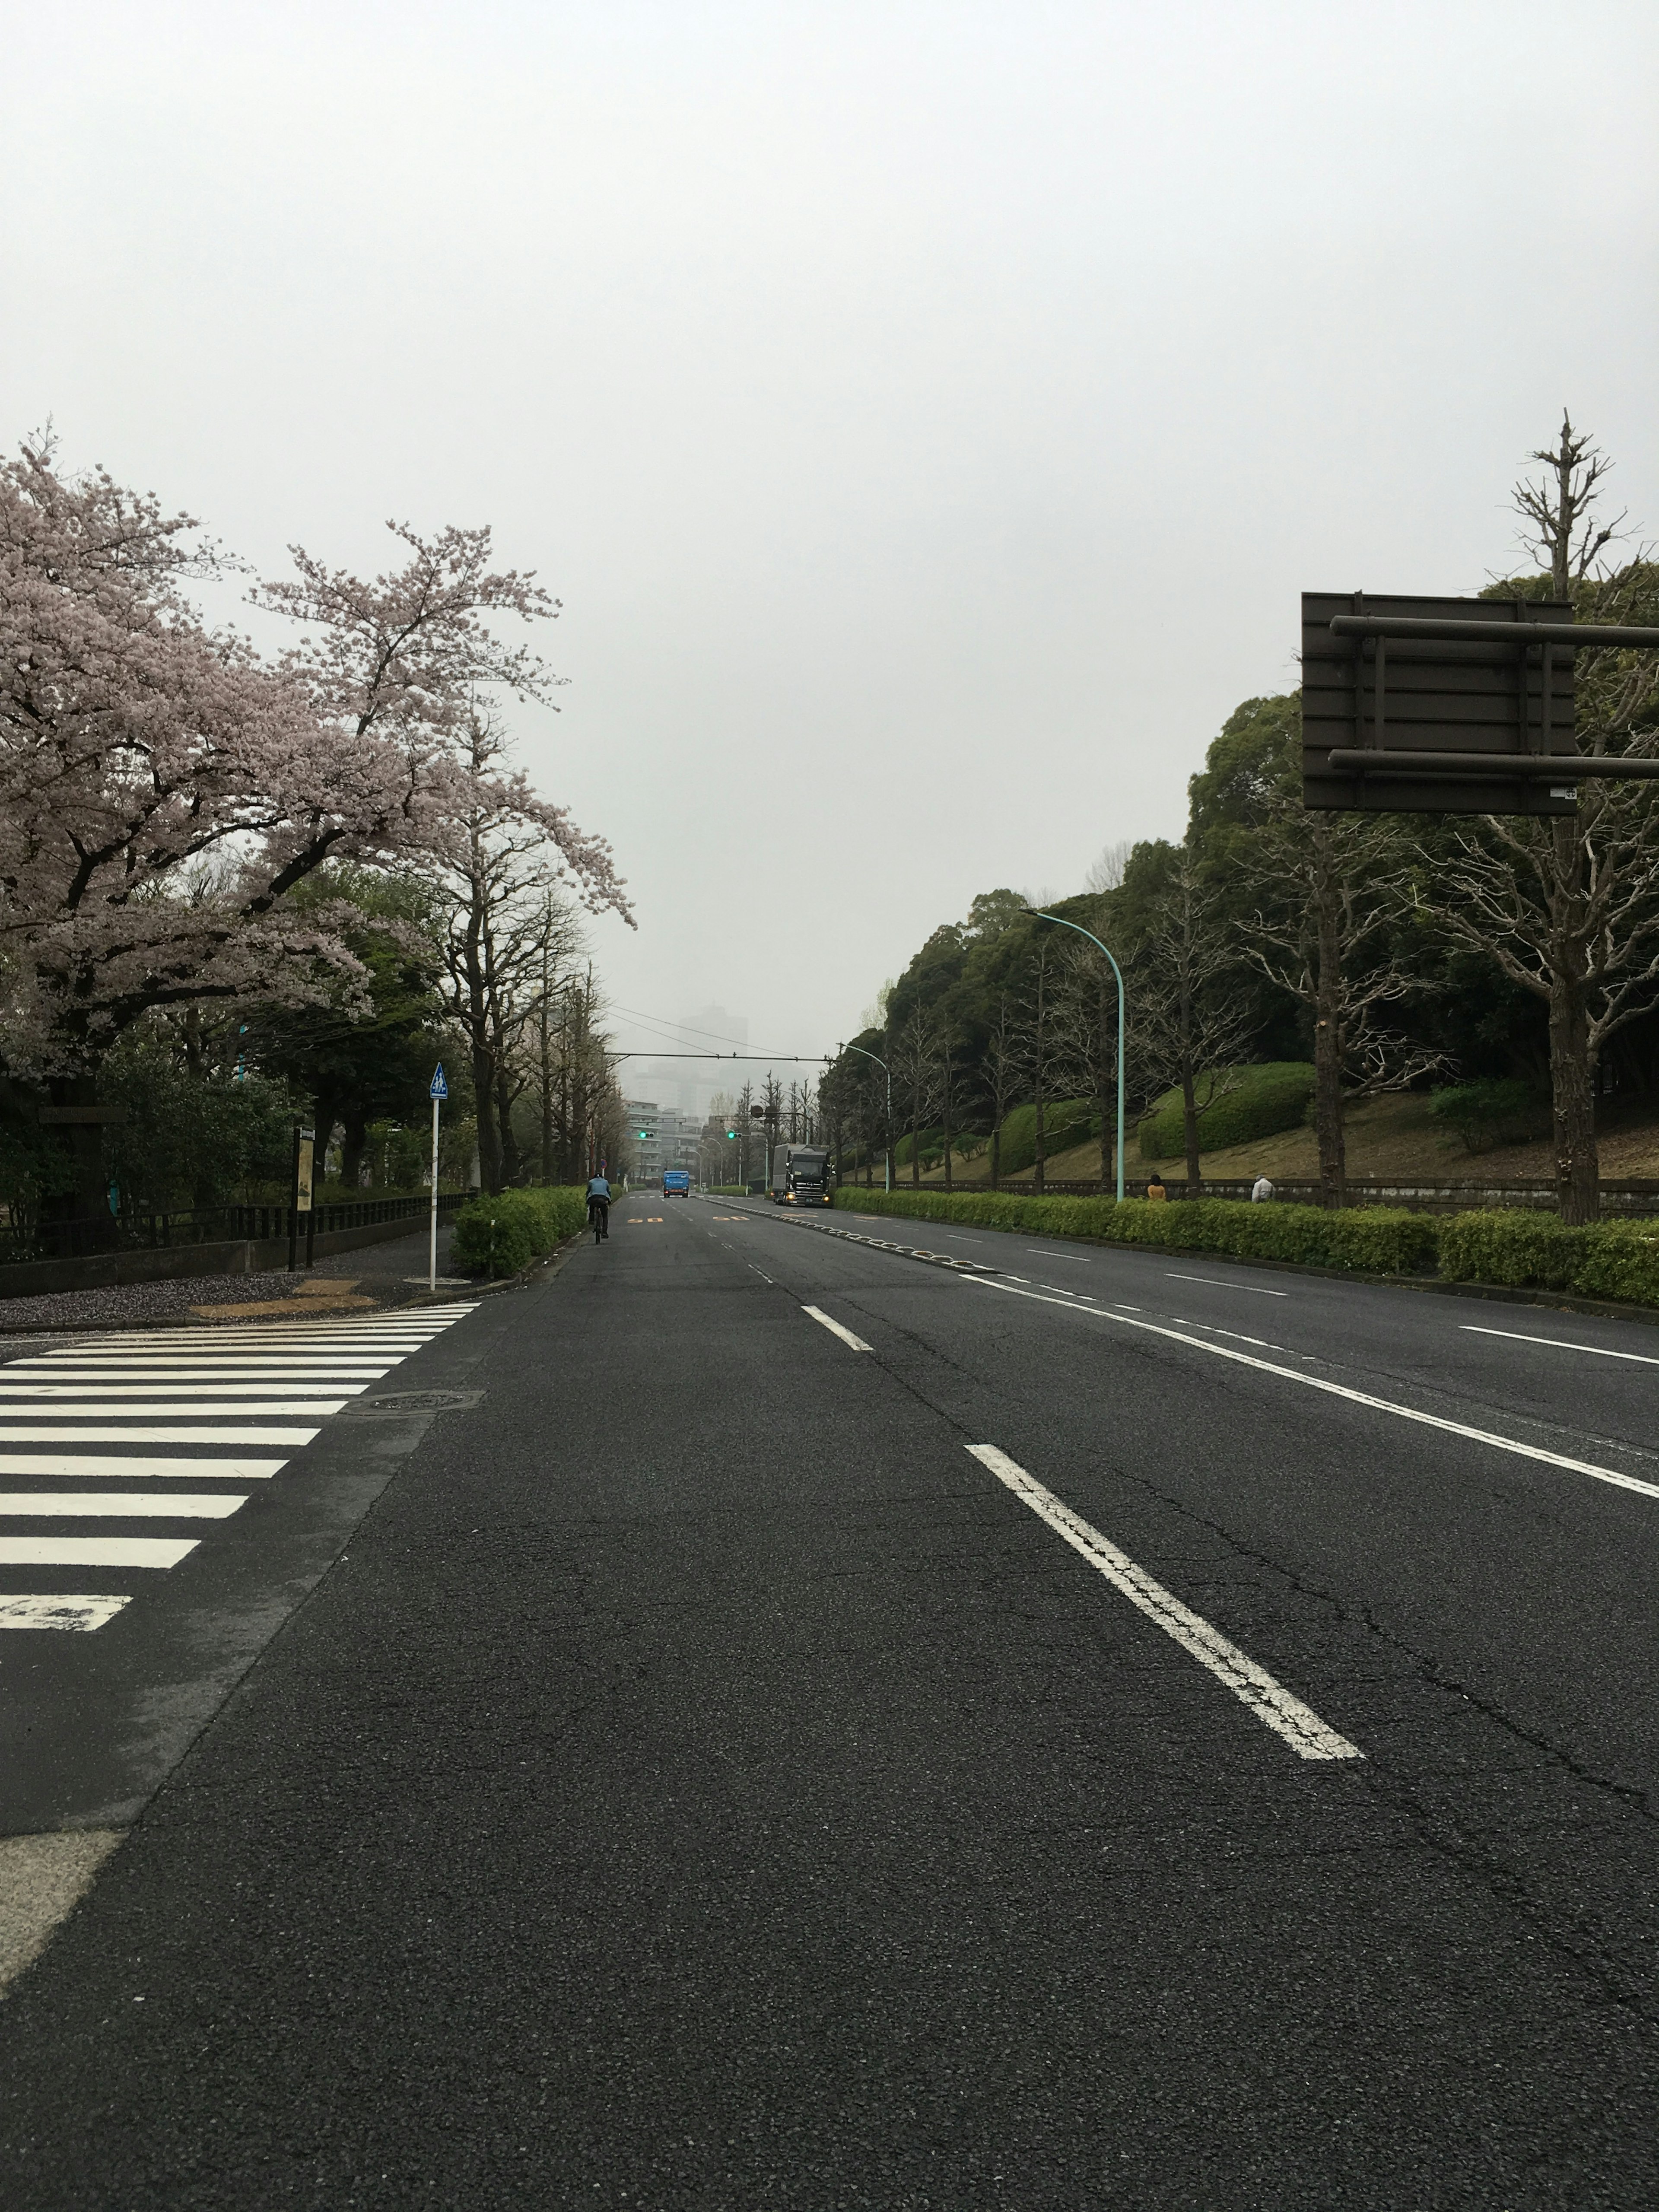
[898,1093,1659,1190]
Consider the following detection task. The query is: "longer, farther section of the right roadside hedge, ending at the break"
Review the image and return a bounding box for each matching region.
[836,1190,1440,1274]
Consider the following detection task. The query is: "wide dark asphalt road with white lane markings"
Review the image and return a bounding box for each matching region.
[0,1197,1659,2212]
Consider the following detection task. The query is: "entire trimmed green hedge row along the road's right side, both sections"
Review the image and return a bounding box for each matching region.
[836,1188,1659,1305]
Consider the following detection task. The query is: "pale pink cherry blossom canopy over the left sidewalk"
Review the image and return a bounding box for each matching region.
[0,447,628,1077]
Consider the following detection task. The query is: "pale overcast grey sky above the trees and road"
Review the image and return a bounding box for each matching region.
[0,0,1659,1088]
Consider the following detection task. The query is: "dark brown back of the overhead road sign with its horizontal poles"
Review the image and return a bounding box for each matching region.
[1303,591,1659,814]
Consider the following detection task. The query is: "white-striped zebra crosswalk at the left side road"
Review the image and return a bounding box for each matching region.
[0,1301,478,1630]
